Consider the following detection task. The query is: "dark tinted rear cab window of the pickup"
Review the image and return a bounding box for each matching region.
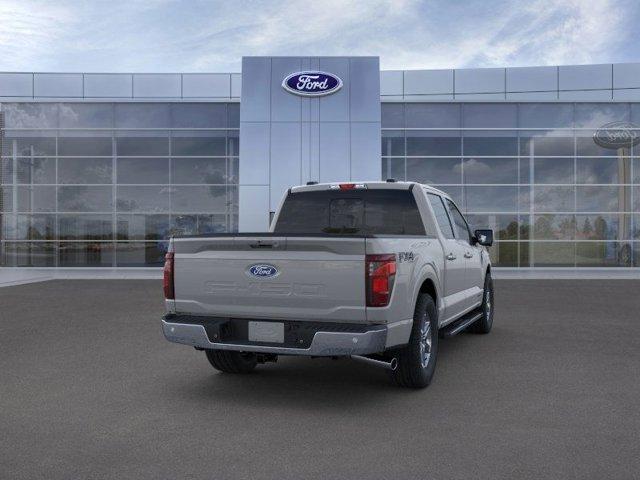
[274,189,425,236]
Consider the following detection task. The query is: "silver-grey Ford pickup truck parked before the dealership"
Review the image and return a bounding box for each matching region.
[162,180,493,388]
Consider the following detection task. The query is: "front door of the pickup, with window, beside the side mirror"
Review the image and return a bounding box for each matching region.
[446,199,484,308]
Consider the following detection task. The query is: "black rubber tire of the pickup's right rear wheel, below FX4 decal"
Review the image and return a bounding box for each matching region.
[391,293,438,388]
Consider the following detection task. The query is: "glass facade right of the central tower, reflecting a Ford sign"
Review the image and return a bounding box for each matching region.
[382,103,640,267]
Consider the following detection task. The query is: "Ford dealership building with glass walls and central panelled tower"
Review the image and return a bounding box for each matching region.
[0,57,640,273]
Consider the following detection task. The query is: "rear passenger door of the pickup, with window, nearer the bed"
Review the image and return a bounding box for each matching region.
[427,193,467,321]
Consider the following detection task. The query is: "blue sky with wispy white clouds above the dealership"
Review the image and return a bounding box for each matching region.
[0,0,640,72]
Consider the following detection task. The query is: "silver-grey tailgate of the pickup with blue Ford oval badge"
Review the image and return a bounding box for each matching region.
[174,235,366,322]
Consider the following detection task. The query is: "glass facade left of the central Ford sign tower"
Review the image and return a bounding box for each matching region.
[0,102,239,267]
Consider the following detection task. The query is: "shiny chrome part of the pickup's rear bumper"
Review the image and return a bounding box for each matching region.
[162,320,387,357]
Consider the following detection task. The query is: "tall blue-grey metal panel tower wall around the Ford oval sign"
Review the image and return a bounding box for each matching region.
[239,57,380,231]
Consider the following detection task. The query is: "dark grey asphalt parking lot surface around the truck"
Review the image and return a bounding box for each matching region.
[0,280,640,480]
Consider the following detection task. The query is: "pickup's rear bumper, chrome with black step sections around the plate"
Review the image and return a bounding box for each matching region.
[162,315,388,357]
